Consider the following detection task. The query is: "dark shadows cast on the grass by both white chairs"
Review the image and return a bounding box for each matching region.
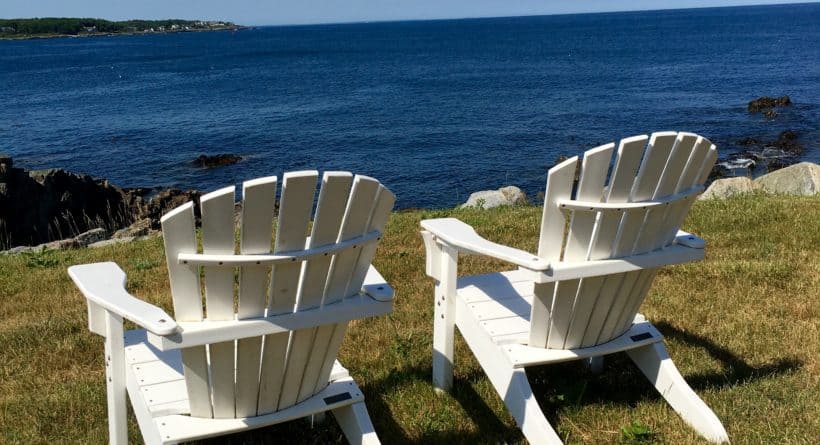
[201,322,803,444]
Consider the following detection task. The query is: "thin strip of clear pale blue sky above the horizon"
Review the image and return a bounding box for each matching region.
[0,0,812,25]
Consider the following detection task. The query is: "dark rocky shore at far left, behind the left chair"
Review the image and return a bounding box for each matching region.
[0,154,200,251]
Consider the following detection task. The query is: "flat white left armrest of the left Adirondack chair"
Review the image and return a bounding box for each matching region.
[68,262,177,335]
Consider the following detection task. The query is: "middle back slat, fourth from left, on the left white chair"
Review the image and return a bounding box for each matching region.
[257,171,319,415]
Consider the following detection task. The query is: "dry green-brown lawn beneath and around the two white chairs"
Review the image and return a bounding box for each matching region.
[0,194,820,444]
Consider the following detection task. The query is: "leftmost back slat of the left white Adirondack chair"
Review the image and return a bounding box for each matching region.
[161,202,213,417]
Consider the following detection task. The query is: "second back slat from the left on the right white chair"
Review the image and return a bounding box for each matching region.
[547,144,615,349]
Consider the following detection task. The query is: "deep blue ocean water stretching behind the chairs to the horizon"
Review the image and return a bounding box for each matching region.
[0,3,820,207]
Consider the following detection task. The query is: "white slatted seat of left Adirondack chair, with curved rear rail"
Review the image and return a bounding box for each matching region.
[125,329,364,443]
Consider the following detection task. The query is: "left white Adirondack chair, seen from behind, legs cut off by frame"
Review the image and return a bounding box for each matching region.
[69,171,395,444]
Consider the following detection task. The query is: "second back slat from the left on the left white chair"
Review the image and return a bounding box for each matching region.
[200,186,236,419]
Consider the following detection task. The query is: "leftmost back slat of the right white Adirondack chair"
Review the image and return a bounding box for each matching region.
[529,157,578,348]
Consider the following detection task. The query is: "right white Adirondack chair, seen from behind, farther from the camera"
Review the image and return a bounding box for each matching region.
[421,132,728,444]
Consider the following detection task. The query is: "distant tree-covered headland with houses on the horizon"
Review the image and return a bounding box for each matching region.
[0,18,234,37]
